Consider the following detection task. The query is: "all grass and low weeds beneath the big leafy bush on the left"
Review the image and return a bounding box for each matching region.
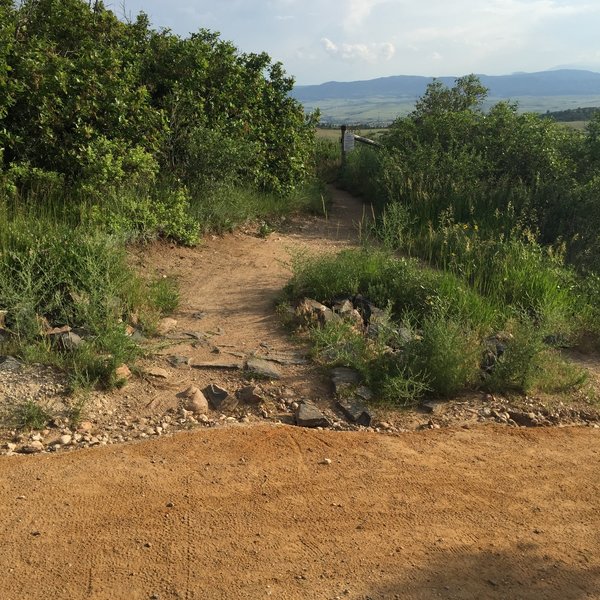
[0,157,327,398]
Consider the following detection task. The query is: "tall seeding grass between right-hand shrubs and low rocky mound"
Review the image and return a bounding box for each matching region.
[338,141,598,343]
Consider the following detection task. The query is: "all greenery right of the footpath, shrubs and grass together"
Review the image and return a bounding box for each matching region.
[288,76,600,403]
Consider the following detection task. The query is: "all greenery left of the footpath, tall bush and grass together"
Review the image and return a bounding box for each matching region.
[0,0,322,398]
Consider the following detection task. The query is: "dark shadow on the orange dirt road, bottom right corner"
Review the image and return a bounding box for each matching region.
[364,544,600,600]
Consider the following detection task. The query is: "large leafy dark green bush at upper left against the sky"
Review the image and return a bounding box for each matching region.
[0,0,313,203]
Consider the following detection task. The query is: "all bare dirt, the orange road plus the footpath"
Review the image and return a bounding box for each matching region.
[0,185,600,600]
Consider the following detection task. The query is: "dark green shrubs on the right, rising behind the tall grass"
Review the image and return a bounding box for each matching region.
[345,76,600,271]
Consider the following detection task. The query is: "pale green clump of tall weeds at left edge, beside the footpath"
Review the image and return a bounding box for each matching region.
[0,206,176,387]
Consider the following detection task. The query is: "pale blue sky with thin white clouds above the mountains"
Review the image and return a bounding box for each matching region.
[116,0,600,84]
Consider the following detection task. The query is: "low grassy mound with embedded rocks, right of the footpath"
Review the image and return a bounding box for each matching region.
[287,248,584,405]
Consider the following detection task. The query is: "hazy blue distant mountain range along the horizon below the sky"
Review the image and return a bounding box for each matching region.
[292,69,600,104]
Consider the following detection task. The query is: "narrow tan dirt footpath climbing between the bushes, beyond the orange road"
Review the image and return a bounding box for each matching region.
[98,185,368,419]
